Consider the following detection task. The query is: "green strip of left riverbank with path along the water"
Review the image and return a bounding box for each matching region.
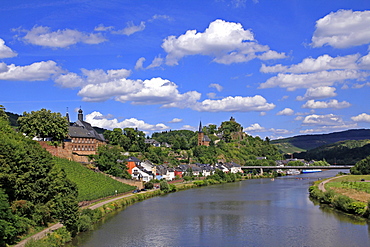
[20,173,274,247]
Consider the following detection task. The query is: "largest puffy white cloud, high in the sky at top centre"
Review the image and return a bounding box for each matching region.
[162,19,283,65]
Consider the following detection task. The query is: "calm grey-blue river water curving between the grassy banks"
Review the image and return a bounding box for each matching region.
[68,170,370,247]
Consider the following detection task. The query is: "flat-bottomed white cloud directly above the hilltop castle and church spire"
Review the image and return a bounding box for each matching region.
[191,95,275,112]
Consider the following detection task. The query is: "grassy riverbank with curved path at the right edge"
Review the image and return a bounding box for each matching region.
[309,175,370,218]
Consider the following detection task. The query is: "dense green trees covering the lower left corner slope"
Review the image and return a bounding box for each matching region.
[0,118,78,244]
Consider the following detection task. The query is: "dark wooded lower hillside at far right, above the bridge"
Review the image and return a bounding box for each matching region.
[294,140,370,165]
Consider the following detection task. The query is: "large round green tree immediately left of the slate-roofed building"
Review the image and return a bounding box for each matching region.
[18,109,68,141]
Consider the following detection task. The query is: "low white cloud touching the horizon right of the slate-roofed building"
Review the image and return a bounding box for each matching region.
[86,111,169,131]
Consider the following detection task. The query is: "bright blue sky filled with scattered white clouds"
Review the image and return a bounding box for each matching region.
[0,0,370,139]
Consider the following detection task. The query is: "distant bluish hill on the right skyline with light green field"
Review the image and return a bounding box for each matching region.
[271,129,370,153]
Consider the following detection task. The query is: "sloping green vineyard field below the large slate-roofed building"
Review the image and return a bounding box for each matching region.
[54,158,135,201]
